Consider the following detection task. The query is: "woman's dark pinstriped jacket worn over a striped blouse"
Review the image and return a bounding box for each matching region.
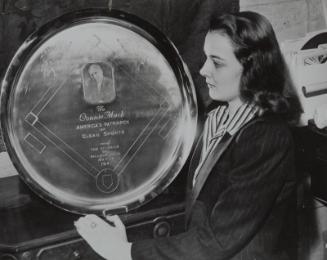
[132,115,297,260]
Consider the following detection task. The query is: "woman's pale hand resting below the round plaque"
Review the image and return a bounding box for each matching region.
[74,215,132,260]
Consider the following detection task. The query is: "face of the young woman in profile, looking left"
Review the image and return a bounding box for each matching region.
[200,31,243,103]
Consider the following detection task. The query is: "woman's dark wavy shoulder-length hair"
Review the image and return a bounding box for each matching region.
[209,12,301,123]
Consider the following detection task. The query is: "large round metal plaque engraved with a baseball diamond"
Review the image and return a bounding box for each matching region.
[1,10,197,214]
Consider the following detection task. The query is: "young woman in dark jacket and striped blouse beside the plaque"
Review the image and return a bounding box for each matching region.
[75,12,297,260]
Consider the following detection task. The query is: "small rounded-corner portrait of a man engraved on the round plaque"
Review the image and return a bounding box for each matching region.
[82,62,116,104]
